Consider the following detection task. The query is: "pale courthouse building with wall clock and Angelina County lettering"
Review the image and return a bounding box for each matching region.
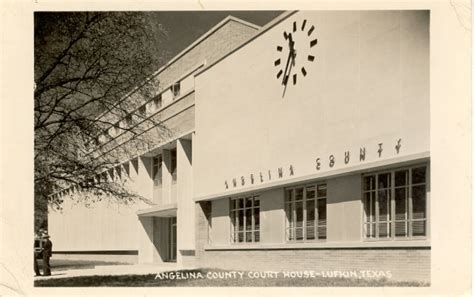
[49,11,431,280]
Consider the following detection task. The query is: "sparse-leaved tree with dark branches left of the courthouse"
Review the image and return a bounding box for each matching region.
[34,12,167,228]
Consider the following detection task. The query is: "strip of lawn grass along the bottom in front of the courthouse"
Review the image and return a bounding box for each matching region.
[35,269,429,287]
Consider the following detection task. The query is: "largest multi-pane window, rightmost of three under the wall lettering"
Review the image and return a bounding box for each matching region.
[363,166,427,239]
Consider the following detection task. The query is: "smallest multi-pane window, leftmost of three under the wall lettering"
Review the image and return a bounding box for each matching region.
[230,196,260,243]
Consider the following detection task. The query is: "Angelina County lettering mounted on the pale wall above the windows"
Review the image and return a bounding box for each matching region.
[224,138,402,190]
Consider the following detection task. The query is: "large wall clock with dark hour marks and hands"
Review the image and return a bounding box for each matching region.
[273,19,318,96]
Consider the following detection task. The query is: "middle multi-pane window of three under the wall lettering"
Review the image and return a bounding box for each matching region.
[285,184,327,241]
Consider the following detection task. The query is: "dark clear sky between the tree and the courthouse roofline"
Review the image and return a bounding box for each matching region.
[146,10,283,64]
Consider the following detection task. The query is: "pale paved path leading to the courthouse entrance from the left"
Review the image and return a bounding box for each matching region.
[34,263,181,280]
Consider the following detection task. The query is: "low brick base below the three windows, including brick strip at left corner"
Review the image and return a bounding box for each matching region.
[196,202,431,282]
